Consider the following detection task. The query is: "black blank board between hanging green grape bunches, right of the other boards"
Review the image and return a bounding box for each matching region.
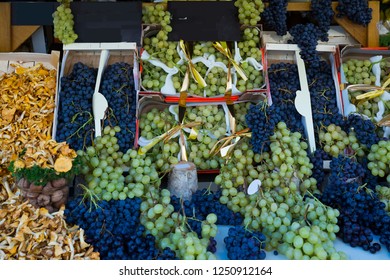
[168,1,241,41]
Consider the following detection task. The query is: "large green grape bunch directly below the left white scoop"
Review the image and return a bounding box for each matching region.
[78,126,161,201]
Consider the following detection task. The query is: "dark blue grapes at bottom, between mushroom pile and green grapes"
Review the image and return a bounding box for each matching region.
[64,198,176,260]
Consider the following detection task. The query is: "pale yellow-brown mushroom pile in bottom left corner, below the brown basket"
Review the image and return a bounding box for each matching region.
[0,177,99,260]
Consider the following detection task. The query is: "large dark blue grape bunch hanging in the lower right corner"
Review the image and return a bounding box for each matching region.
[319,156,390,253]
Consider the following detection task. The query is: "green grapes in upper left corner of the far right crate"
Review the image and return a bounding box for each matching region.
[342,59,376,85]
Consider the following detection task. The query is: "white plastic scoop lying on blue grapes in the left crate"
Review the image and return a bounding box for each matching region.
[92,50,109,137]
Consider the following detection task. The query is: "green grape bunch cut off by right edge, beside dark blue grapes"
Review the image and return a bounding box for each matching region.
[367,140,390,183]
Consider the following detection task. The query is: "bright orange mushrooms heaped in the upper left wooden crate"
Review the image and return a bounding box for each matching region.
[0,64,57,175]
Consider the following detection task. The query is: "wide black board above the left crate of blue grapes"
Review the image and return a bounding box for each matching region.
[71,1,142,44]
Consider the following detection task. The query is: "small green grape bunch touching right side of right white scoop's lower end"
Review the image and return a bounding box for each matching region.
[318,124,364,157]
